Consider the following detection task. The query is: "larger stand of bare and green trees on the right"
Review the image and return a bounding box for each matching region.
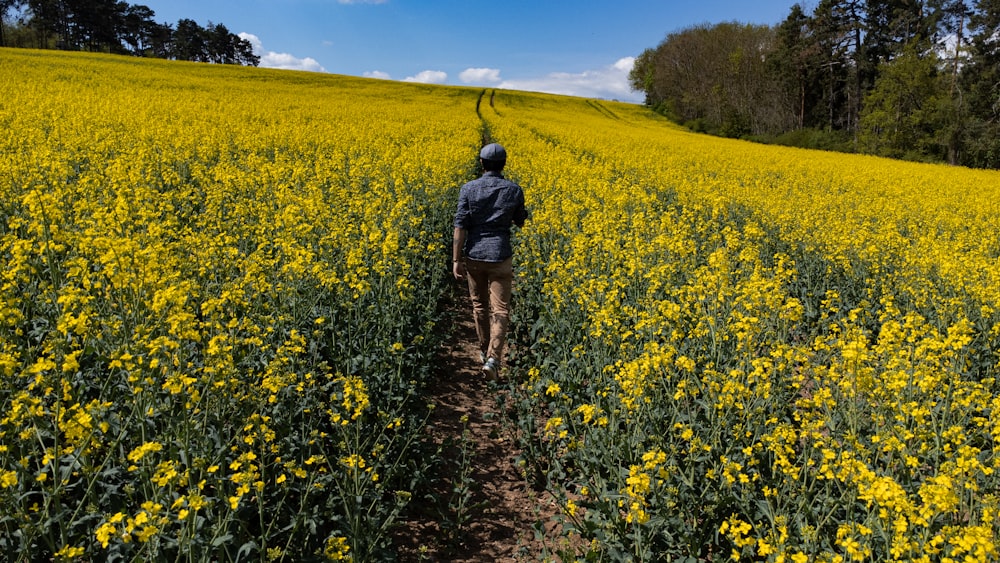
[629,0,1000,168]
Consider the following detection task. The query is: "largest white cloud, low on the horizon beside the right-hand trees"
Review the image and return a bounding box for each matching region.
[497,57,644,102]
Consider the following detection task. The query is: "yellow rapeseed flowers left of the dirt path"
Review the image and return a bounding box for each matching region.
[0,50,480,561]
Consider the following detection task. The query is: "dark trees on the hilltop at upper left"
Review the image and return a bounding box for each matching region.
[0,0,260,66]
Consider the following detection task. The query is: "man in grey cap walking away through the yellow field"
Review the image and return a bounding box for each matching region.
[452,143,528,379]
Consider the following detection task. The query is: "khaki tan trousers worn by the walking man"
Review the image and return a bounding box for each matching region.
[465,258,514,362]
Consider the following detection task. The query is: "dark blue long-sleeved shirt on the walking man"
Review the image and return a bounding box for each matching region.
[455,171,528,262]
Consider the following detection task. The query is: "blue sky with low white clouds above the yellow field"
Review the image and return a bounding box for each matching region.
[132,0,811,102]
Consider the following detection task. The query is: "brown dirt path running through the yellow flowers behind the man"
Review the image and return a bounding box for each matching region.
[396,283,556,563]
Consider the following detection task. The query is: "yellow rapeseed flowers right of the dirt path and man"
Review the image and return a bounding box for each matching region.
[484,93,1000,562]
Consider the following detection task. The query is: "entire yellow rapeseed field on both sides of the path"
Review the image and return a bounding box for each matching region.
[0,49,1000,562]
